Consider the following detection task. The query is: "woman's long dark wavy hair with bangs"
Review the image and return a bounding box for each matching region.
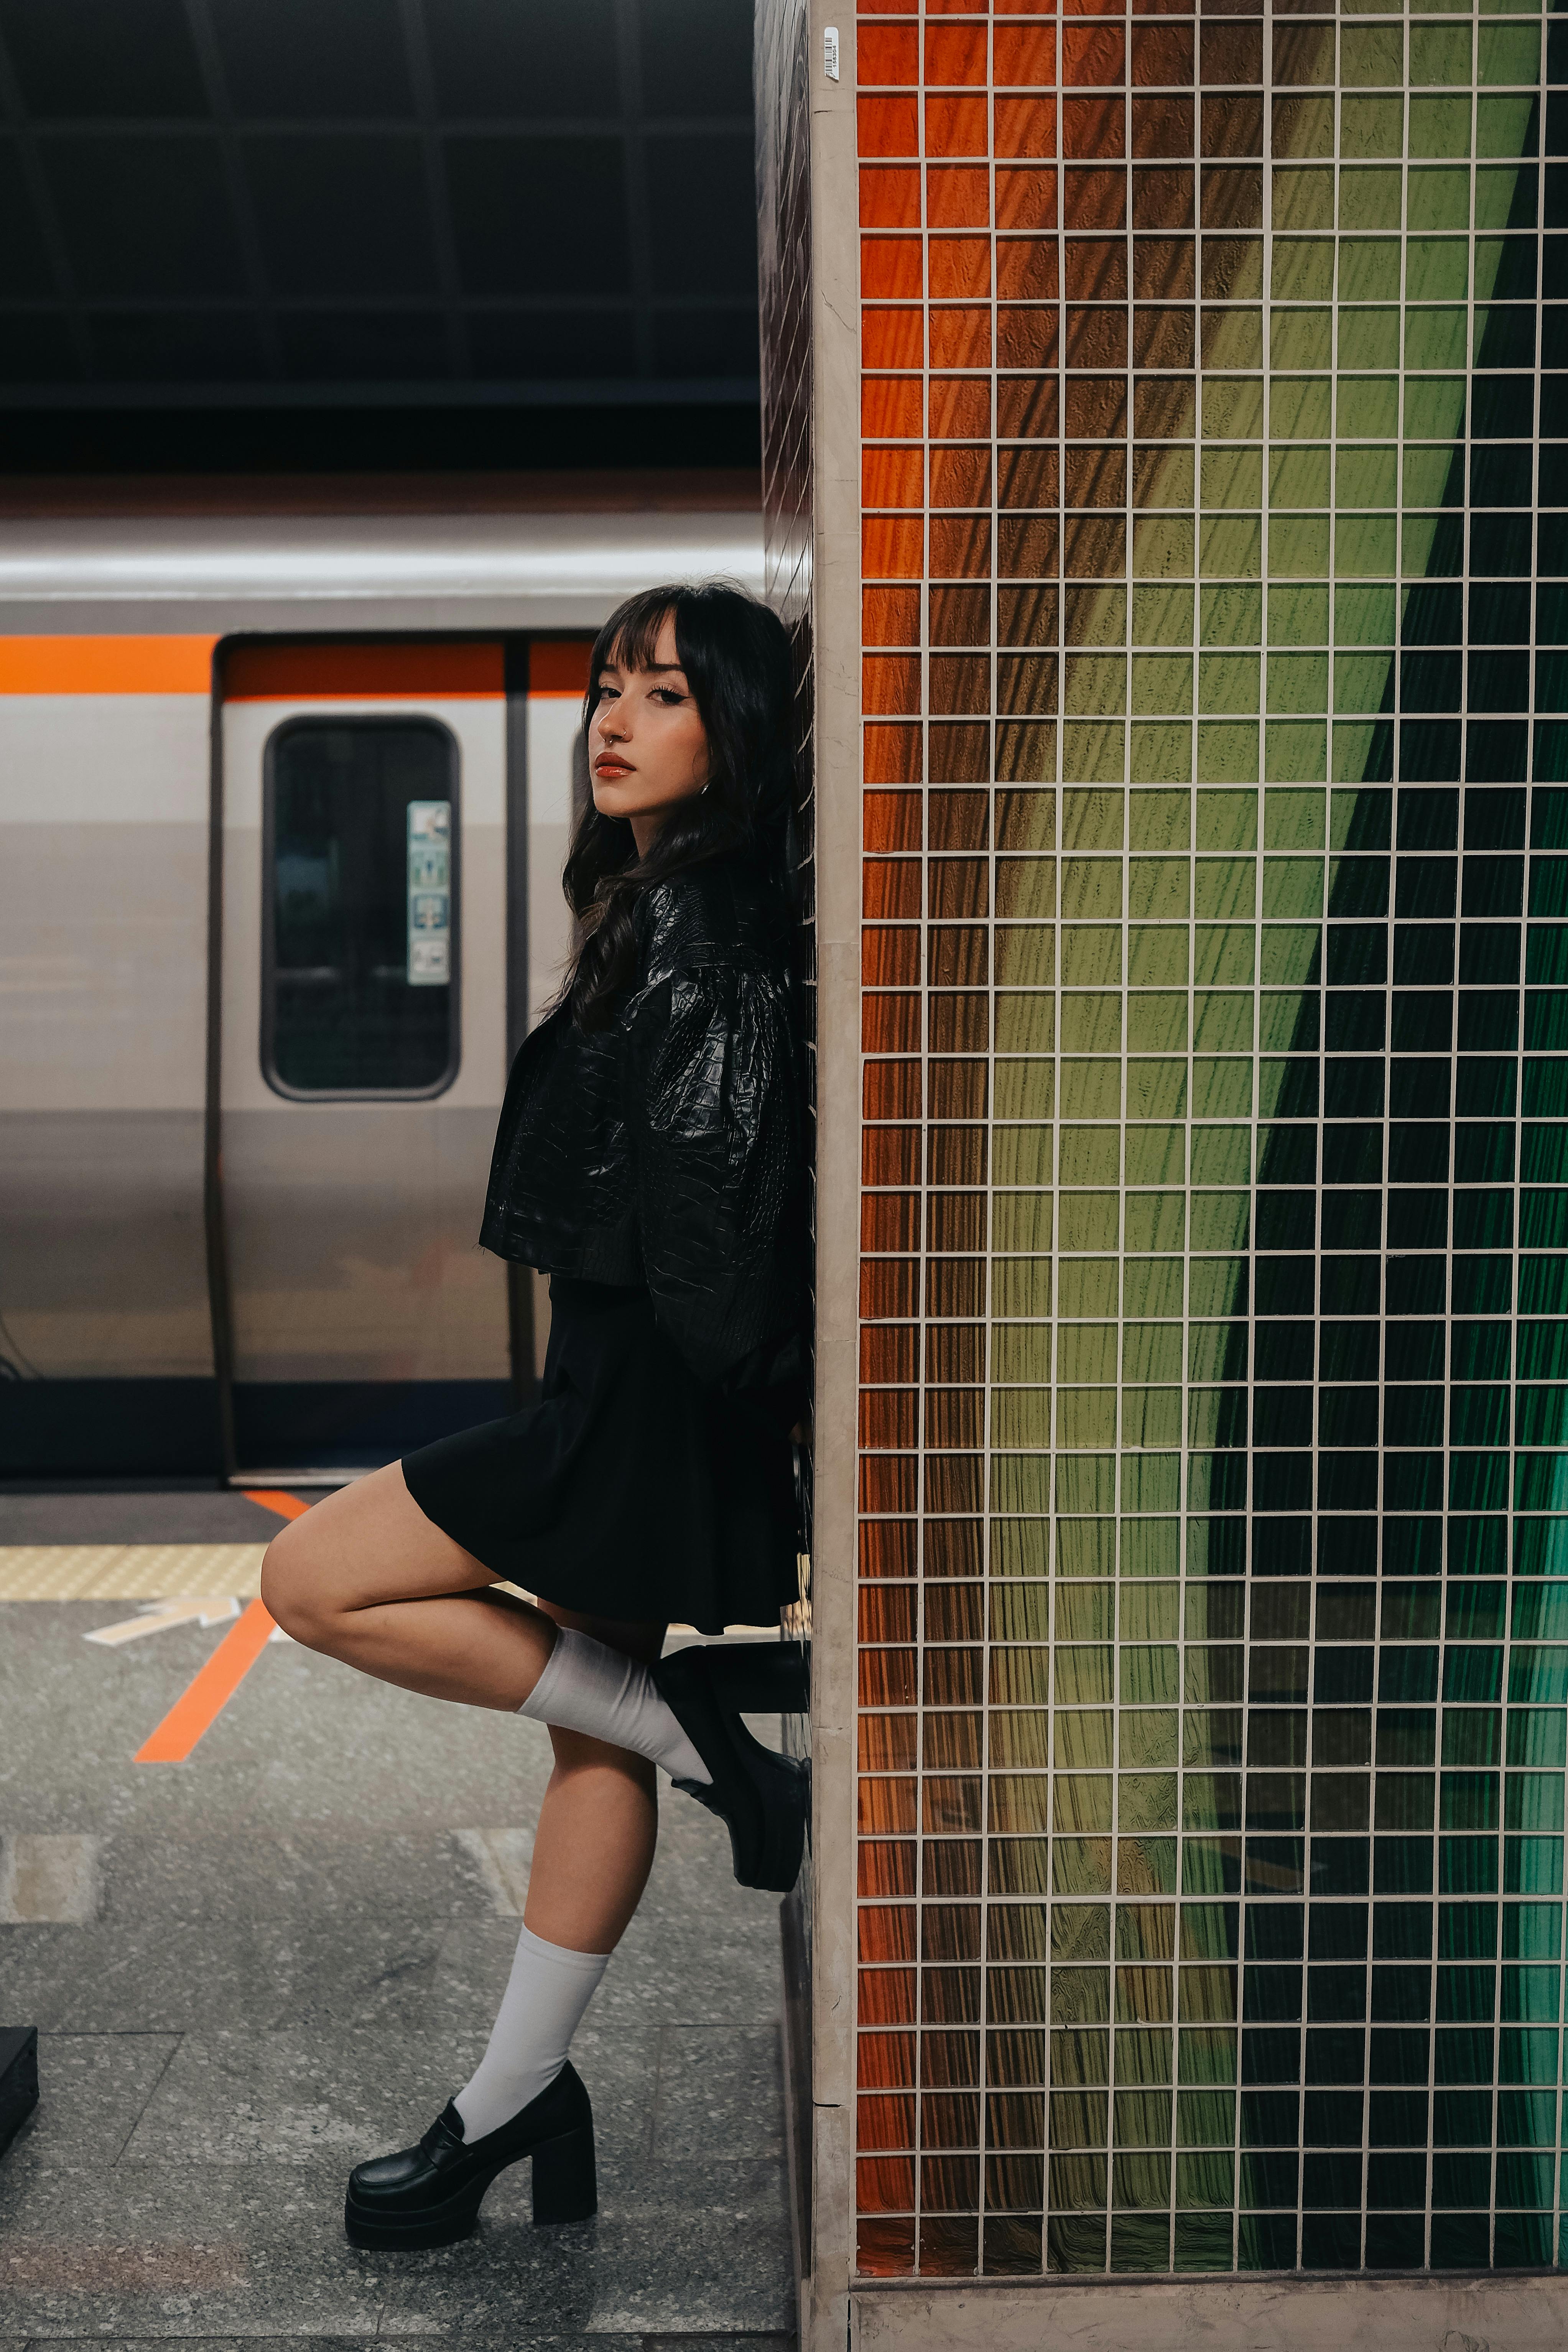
[557,581,792,1030]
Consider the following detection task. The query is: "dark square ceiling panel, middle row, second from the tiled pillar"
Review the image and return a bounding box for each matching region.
[447,137,630,294]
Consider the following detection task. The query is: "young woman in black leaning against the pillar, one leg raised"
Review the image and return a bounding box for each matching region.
[261,586,806,2246]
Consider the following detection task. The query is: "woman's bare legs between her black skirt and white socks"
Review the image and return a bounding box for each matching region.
[261,1463,663,1952]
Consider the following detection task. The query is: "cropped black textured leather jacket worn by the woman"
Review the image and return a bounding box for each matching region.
[480,859,806,1388]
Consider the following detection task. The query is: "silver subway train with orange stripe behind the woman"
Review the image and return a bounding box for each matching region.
[0,475,762,1484]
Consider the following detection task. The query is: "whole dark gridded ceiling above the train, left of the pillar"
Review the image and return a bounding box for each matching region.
[0,0,762,409]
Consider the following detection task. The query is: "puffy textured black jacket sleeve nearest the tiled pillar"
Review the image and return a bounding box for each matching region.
[625,960,804,1381]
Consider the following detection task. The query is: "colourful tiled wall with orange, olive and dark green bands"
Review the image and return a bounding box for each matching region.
[856,0,1568,2277]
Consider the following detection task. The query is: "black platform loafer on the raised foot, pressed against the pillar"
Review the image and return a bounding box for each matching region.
[653,1642,811,1896]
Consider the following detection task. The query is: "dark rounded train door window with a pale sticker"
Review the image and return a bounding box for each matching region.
[261,720,458,1096]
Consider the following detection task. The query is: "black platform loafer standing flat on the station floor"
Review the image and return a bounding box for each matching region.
[343,2065,599,2251]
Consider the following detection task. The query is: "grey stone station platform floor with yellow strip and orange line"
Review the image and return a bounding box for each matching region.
[0,1491,795,2352]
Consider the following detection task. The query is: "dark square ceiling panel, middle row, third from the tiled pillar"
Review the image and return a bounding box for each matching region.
[242,132,437,296]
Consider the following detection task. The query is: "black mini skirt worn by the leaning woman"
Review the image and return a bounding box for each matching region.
[402,1275,799,1632]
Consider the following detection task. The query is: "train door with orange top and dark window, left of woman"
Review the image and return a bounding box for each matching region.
[219,642,512,1472]
